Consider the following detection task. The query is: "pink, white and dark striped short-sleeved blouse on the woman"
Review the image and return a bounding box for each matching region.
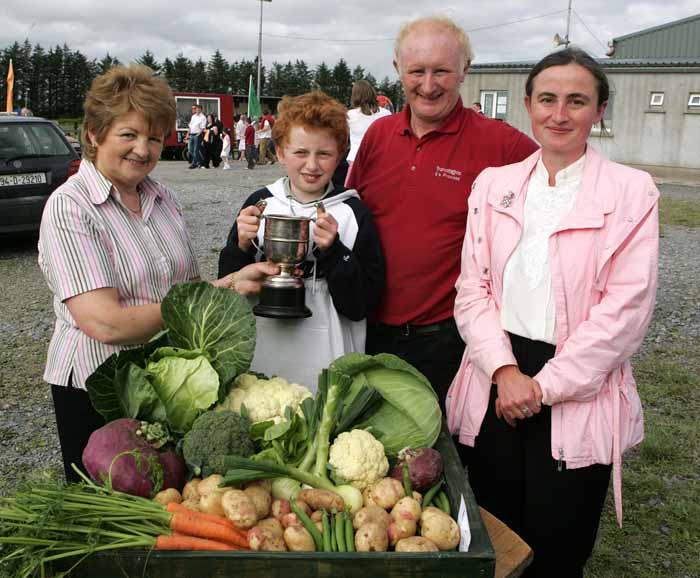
[39,160,199,389]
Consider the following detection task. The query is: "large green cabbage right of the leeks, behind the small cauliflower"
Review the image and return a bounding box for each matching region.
[331,353,442,456]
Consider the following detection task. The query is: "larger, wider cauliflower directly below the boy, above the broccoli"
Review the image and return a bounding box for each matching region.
[217,373,312,423]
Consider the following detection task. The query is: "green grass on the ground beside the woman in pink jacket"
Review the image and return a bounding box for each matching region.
[586,344,700,578]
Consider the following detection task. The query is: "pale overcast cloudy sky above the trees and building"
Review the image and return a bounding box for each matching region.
[0,0,700,80]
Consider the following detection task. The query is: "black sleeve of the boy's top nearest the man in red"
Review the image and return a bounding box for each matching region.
[317,199,384,321]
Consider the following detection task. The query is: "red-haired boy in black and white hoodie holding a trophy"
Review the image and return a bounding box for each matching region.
[219,92,384,390]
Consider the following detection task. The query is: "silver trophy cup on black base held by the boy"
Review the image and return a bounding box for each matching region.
[253,215,311,319]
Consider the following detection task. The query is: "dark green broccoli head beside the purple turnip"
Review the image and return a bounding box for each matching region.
[182,410,255,476]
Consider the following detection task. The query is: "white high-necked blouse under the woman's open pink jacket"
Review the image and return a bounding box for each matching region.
[501,155,586,344]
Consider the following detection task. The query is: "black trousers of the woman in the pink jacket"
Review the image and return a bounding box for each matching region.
[459,335,611,578]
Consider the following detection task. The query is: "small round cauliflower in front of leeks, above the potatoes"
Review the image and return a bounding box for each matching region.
[328,429,389,490]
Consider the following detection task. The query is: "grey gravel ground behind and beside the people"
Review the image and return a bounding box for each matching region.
[0,162,700,494]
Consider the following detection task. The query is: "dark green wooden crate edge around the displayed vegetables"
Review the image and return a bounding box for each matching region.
[60,428,496,578]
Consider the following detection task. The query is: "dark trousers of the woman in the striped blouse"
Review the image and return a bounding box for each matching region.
[51,385,105,482]
